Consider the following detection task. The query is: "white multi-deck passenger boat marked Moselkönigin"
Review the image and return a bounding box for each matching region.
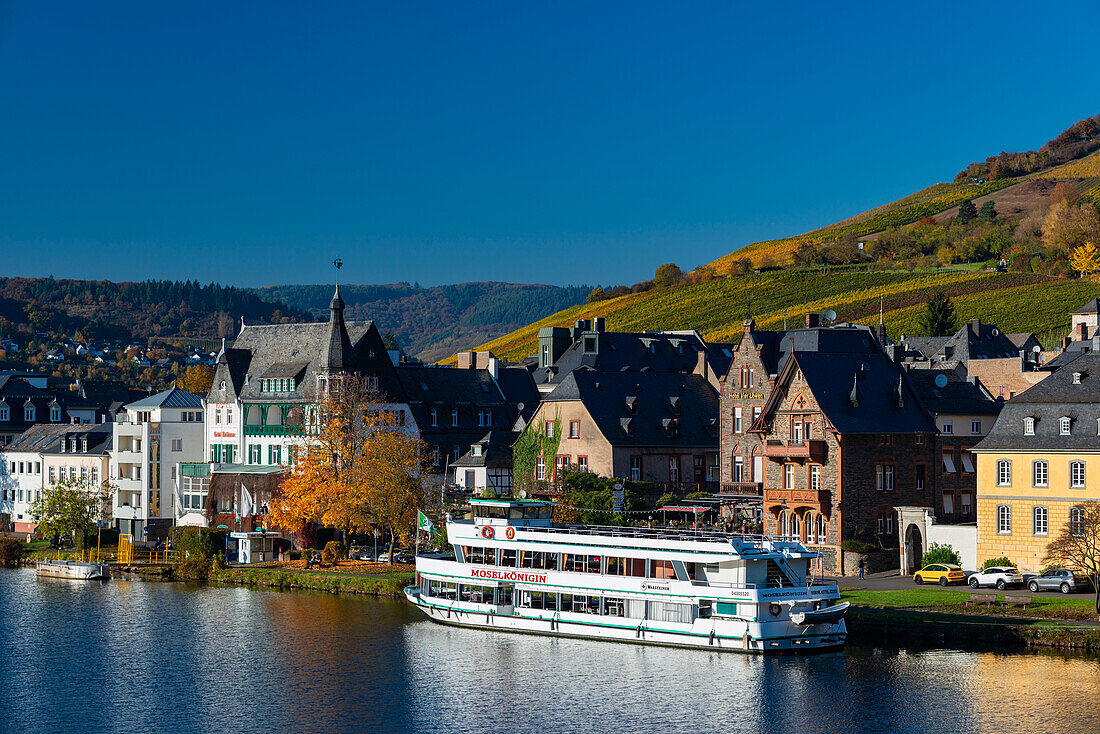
[405,499,848,653]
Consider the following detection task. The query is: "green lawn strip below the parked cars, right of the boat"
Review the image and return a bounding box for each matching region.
[840,589,1097,622]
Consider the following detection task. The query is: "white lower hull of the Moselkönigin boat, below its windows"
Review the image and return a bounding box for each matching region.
[405,587,847,653]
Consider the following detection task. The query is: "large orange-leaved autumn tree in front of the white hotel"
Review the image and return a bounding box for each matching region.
[267,375,427,562]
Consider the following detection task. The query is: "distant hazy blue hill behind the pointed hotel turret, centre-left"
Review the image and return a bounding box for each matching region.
[256,283,592,360]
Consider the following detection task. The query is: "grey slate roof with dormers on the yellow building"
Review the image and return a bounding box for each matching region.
[975,353,1100,452]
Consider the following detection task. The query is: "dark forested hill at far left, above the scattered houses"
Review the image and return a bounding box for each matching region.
[0,277,310,340]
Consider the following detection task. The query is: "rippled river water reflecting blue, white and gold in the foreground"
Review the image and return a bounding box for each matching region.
[0,570,1100,734]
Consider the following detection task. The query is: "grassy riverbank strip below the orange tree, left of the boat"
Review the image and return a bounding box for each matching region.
[209,568,414,599]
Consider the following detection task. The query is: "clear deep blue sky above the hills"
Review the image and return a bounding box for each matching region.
[0,0,1100,285]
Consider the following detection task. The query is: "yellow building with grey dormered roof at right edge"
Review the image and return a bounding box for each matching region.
[972,353,1100,571]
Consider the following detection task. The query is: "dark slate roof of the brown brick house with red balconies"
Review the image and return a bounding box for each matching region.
[765,351,937,434]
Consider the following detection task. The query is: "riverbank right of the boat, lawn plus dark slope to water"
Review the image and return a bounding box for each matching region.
[842,589,1100,651]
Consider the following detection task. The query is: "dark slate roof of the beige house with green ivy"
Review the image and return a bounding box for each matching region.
[543,371,718,449]
